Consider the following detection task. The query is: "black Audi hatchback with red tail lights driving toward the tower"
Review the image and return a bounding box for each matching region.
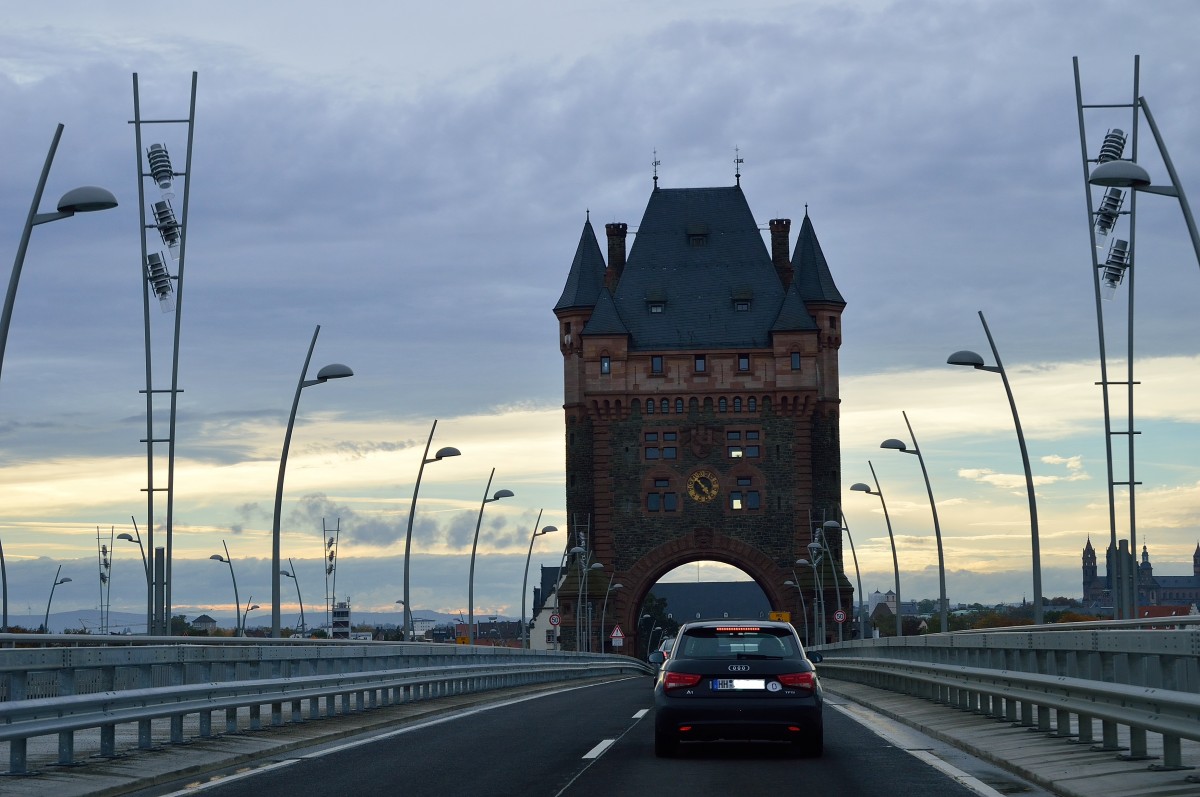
[654,619,824,757]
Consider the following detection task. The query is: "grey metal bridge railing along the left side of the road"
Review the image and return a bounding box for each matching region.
[0,635,650,774]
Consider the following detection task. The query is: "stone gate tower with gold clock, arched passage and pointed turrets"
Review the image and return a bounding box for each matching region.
[554,185,853,652]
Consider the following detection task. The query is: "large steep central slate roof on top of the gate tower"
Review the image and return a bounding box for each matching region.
[592,186,796,350]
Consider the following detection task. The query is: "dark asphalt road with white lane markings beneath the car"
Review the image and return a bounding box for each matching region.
[143,678,1032,797]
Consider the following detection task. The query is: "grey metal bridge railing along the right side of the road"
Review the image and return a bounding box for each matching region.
[814,618,1200,768]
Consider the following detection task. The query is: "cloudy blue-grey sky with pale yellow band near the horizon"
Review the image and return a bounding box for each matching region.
[0,0,1200,624]
